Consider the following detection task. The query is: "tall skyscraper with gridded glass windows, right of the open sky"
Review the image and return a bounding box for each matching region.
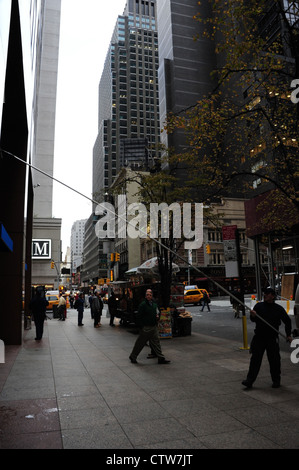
[93,0,160,200]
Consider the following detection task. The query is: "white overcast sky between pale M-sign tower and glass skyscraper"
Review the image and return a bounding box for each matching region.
[53,0,126,259]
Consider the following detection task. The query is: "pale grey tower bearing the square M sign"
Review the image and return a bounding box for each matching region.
[32,0,62,289]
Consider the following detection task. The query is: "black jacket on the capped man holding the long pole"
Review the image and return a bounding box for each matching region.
[250,302,292,338]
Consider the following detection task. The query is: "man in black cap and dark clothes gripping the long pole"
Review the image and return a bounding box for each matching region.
[242,288,292,388]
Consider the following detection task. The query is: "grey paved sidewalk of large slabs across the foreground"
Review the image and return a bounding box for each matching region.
[0,309,299,455]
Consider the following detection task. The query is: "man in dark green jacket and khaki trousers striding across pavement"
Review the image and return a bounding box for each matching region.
[129,289,170,364]
